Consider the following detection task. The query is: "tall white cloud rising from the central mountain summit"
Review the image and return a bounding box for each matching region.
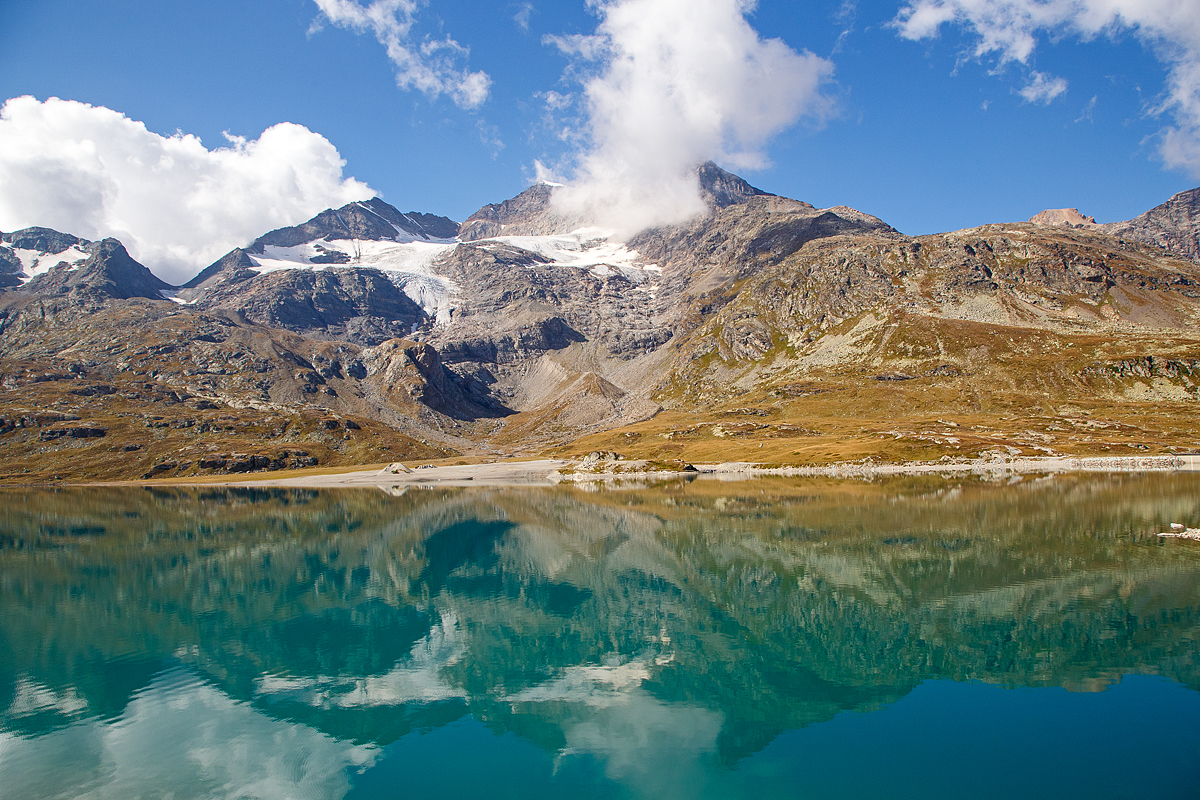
[547,0,833,235]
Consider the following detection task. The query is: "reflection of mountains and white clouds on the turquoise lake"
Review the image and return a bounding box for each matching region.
[0,475,1200,798]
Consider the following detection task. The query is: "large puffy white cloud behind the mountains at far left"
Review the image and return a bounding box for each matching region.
[0,97,374,283]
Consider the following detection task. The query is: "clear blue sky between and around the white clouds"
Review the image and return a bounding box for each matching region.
[0,0,1200,281]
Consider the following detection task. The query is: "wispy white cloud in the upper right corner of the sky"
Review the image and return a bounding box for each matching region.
[895,0,1200,178]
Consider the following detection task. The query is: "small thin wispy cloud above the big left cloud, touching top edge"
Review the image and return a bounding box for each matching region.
[316,0,492,109]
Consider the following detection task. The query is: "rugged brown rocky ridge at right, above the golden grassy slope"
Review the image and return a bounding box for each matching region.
[662,219,1200,402]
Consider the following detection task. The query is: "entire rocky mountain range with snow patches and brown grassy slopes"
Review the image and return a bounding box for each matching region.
[0,163,1200,481]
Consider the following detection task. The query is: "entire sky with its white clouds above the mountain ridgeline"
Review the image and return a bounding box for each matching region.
[0,0,1200,281]
